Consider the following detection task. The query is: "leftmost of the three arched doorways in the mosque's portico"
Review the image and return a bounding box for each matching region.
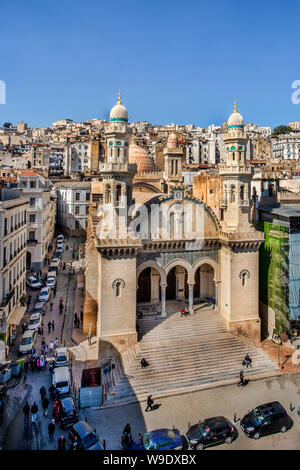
[137,267,160,303]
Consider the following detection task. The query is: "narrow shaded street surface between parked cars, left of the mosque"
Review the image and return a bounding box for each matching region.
[3,239,79,450]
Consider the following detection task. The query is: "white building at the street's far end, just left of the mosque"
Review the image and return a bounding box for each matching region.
[55,181,91,236]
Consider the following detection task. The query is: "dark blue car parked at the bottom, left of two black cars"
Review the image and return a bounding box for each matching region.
[131,429,183,450]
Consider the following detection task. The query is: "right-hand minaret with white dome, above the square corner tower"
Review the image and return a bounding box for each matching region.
[219,101,252,232]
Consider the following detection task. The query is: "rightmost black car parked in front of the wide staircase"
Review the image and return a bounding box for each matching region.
[240,401,293,439]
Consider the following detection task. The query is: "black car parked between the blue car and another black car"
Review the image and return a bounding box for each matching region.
[186,416,238,450]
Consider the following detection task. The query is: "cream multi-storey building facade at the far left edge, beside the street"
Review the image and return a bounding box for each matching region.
[0,197,28,347]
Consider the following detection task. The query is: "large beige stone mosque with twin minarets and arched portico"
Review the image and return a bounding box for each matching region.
[83,94,263,352]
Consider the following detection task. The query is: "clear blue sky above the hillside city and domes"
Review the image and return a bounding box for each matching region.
[0,0,300,126]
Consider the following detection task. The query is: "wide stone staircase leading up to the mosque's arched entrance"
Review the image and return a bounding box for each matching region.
[104,305,277,406]
